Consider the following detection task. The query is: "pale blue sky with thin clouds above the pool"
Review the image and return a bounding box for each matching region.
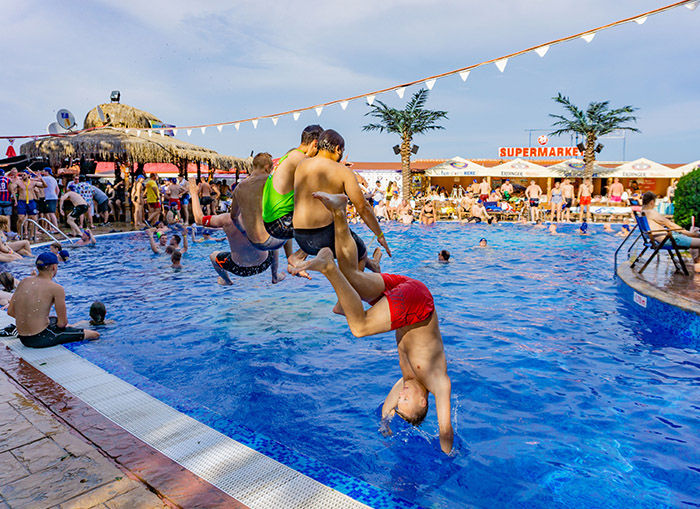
[0,0,700,163]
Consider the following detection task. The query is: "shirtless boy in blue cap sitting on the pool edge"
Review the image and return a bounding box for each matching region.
[7,252,100,348]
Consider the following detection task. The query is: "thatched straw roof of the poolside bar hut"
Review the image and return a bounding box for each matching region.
[20,103,251,175]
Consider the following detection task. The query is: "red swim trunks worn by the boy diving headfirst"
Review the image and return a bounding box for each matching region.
[381,274,435,330]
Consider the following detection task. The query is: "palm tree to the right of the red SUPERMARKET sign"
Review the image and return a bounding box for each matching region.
[549,92,640,178]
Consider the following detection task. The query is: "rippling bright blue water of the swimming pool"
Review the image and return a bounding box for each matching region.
[6,223,700,508]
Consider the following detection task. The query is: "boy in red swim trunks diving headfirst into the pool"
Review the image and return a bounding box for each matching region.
[299,192,453,454]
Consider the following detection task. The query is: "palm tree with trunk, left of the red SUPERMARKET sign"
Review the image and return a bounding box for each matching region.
[362,88,447,200]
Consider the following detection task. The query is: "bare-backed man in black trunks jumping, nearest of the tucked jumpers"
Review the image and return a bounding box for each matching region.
[291,129,391,272]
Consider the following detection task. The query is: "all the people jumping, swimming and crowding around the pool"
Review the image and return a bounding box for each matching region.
[0,125,700,453]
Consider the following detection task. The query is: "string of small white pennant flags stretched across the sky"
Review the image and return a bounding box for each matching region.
[0,0,700,140]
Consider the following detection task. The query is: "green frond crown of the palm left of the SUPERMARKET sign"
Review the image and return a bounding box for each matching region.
[362,88,447,140]
